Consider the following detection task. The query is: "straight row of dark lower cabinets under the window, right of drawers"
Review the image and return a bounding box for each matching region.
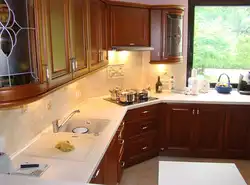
[163,104,250,159]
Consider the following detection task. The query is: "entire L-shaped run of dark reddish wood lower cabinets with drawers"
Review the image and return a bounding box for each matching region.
[91,104,250,185]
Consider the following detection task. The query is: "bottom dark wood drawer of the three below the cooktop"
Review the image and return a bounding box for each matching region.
[125,131,157,159]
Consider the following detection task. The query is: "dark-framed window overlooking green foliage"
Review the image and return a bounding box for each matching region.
[188,0,250,86]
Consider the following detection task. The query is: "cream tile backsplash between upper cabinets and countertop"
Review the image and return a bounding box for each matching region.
[0,52,188,155]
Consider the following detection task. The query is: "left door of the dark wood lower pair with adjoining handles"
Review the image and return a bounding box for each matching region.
[166,104,195,152]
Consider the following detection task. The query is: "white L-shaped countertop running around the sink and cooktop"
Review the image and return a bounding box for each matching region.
[0,91,250,183]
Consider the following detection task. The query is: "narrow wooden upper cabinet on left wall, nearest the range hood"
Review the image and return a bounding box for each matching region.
[90,0,108,71]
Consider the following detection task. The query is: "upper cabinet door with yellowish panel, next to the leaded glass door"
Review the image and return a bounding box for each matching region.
[42,0,73,88]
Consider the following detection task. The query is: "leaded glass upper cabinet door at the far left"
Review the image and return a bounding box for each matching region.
[0,0,39,87]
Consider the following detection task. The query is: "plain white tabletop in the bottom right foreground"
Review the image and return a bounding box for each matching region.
[159,161,247,185]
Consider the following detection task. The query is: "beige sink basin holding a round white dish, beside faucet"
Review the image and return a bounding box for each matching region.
[59,119,110,136]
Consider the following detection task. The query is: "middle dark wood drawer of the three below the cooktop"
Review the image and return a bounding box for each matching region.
[124,119,158,139]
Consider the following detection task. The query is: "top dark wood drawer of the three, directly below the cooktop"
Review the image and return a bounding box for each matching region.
[124,105,157,121]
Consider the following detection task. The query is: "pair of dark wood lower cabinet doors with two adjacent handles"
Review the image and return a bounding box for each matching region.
[166,104,226,157]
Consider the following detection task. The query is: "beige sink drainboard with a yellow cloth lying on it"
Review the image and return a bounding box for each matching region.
[24,133,95,162]
